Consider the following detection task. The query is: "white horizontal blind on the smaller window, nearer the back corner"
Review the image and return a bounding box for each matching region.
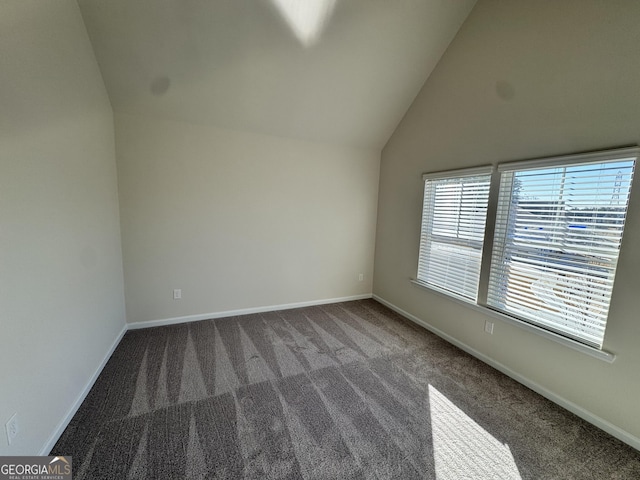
[418,167,492,301]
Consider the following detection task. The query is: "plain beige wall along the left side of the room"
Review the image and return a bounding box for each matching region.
[0,0,125,455]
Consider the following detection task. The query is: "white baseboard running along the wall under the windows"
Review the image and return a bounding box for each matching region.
[372,294,640,450]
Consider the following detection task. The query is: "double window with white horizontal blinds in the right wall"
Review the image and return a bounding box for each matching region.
[417,144,640,349]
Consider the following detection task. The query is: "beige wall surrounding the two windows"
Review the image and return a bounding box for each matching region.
[374,0,640,437]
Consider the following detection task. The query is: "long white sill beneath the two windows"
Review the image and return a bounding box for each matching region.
[411,279,616,363]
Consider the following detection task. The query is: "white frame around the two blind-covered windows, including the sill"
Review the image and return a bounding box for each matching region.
[411,146,640,362]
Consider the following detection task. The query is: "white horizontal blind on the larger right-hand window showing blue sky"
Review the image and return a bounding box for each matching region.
[487,149,637,348]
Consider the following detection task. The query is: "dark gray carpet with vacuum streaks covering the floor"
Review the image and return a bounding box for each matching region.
[51,300,640,480]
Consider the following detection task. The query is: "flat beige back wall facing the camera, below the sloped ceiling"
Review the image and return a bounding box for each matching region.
[115,114,380,322]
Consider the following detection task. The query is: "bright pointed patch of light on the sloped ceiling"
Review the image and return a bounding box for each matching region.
[271,0,336,47]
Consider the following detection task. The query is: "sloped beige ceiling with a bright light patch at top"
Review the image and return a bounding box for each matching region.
[78,0,475,149]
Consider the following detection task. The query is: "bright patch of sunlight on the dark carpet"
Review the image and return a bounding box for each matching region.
[429,385,522,480]
